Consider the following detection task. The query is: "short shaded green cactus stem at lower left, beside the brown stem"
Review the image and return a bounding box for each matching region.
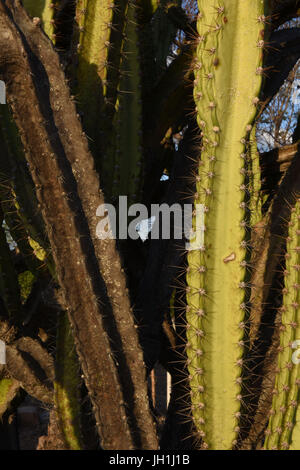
[54,312,82,450]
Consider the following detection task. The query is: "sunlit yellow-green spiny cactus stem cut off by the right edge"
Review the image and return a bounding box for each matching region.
[264,200,300,450]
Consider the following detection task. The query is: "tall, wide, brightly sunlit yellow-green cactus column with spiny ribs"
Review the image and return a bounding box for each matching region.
[186,0,265,450]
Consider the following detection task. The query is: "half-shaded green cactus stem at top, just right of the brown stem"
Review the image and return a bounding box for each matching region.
[74,0,128,172]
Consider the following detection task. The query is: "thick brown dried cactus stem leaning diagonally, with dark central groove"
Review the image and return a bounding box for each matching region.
[0,1,157,449]
